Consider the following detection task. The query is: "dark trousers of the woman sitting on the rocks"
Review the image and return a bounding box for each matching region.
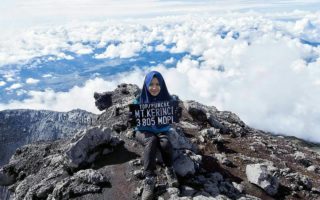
[136,132,173,176]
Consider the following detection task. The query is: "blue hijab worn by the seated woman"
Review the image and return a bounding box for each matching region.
[140,71,171,103]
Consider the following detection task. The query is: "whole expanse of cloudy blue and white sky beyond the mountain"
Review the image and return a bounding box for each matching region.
[0,0,320,142]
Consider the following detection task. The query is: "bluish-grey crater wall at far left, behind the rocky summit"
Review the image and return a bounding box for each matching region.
[0,110,98,166]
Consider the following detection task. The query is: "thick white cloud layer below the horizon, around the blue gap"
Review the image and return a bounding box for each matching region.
[0,11,320,142]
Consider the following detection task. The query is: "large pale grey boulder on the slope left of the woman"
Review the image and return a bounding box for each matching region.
[65,127,122,168]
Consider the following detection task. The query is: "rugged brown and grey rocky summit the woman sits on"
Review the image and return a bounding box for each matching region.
[0,84,320,200]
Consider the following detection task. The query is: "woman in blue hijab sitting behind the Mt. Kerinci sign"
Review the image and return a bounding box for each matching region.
[133,71,181,200]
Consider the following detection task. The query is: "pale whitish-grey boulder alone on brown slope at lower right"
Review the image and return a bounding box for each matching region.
[246,164,279,195]
